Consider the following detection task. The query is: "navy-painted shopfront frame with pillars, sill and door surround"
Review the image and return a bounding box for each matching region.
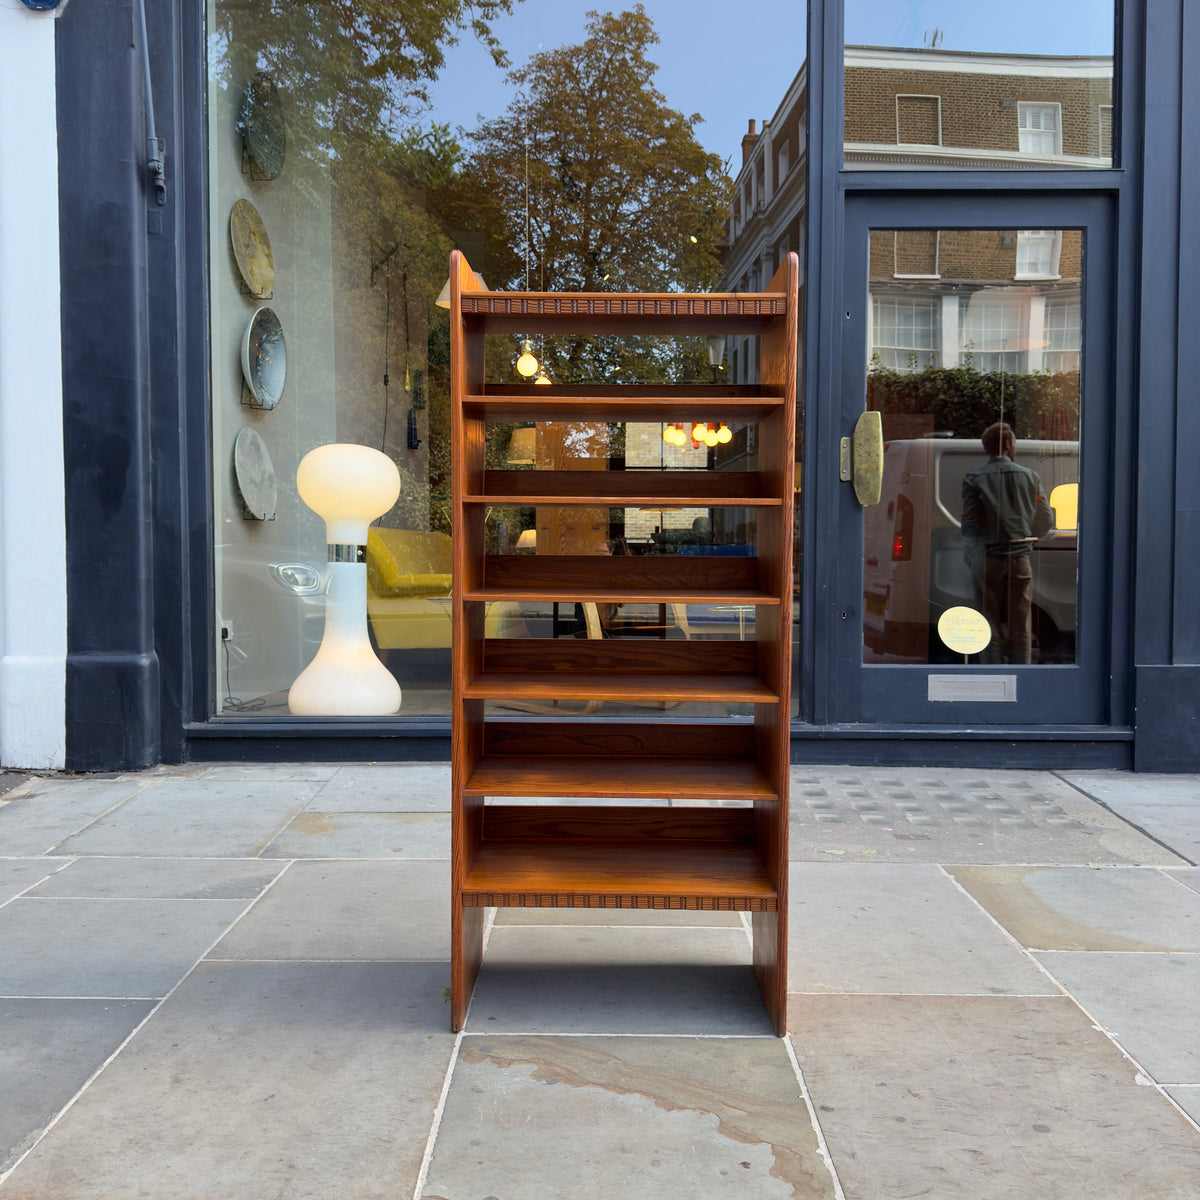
[58,0,1200,770]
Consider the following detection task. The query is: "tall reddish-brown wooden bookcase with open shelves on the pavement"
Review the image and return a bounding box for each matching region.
[450,251,799,1034]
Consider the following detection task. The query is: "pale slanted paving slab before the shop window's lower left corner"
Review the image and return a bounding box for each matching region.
[53,779,320,858]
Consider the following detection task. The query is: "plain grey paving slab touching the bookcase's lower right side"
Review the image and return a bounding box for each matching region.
[787,863,1054,996]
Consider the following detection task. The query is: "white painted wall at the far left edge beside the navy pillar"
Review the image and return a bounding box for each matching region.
[0,0,67,768]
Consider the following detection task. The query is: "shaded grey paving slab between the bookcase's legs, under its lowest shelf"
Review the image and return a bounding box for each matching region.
[467,925,770,1034]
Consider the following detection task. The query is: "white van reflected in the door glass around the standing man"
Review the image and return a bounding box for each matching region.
[863,436,1079,664]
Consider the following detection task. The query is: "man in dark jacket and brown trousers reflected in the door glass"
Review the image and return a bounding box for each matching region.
[962,421,1052,662]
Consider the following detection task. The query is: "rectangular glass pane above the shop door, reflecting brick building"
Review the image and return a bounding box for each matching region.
[844,0,1115,170]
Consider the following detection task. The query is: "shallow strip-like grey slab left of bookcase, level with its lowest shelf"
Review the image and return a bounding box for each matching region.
[30,858,284,900]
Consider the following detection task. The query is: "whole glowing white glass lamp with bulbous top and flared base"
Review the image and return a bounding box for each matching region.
[288,444,401,716]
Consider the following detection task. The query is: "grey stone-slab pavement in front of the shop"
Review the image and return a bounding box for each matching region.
[0,763,1200,1200]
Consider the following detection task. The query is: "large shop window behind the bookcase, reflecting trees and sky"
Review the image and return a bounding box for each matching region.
[208,0,805,716]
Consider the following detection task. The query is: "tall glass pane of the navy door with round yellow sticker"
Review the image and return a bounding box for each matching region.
[863,229,1084,665]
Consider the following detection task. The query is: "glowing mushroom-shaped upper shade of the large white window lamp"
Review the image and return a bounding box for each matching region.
[296,443,400,546]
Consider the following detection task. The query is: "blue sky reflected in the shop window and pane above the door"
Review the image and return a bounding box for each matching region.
[431,0,1112,166]
